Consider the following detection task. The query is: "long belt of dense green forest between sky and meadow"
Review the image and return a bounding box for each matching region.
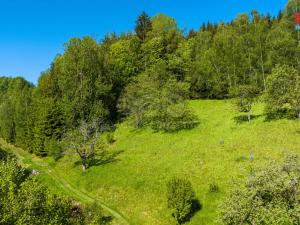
[0,0,300,156]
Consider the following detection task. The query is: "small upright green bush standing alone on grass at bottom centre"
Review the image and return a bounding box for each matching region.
[167,178,197,224]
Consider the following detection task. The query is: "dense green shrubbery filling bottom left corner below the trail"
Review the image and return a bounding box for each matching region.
[0,149,111,225]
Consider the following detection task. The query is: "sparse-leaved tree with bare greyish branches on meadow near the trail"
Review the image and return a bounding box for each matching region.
[66,120,107,172]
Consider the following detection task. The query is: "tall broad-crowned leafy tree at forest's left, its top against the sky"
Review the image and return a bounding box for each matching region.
[51,37,111,127]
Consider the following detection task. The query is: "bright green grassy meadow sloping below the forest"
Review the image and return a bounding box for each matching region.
[3,100,300,225]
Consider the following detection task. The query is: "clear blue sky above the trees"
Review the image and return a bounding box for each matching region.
[0,0,287,83]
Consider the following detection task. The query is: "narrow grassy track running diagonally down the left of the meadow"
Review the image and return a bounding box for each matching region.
[0,140,131,225]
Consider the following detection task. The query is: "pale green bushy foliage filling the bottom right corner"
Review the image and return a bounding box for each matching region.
[220,156,300,225]
